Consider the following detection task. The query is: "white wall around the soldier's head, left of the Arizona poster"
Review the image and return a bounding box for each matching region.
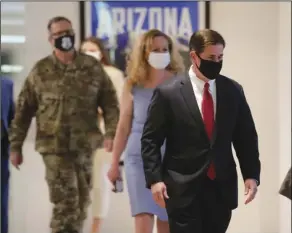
[15,2,80,94]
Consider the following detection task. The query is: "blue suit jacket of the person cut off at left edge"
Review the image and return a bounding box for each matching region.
[1,77,14,156]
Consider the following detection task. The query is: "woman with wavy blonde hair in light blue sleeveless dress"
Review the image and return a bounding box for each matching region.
[108,29,183,233]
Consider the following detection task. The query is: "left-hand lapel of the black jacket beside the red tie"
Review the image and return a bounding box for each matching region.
[180,75,208,140]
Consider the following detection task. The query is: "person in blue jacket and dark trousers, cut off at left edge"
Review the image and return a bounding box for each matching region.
[1,77,14,233]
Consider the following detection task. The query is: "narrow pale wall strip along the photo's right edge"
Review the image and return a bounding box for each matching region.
[278,2,291,233]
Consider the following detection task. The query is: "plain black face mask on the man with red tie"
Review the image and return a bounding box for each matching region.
[198,57,223,80]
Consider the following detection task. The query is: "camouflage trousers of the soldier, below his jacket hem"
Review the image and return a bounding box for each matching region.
[43,152,93,233]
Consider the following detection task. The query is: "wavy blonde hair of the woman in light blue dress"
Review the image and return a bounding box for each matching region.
[126,29,184,88]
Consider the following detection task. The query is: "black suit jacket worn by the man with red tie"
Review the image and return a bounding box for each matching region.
[141,75,260,209]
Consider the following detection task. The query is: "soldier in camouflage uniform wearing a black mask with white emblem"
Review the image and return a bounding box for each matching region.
[10,17,119,233]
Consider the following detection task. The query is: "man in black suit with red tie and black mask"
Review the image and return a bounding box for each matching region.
[141,29,260,233]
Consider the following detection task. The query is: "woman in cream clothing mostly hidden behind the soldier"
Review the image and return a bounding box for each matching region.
[80,37,124,233]
